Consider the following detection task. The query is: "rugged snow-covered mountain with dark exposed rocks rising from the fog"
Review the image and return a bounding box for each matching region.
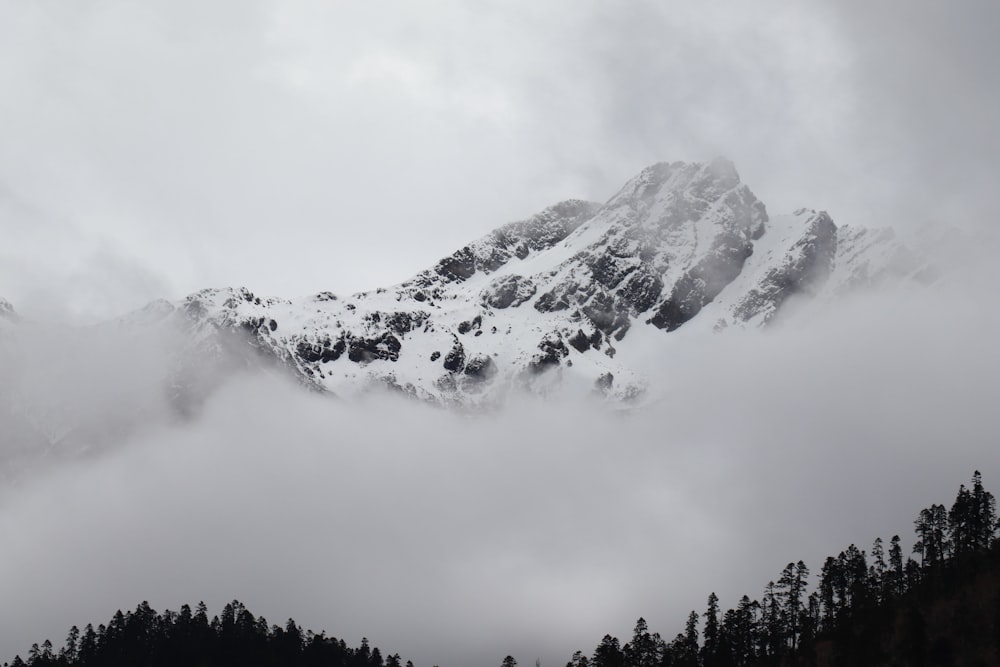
[82,159,923,406]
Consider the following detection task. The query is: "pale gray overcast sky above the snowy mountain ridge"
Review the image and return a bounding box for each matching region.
[0,0,1000,321]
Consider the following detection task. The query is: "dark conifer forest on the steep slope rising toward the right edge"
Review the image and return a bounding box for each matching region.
[566,471,1000,667]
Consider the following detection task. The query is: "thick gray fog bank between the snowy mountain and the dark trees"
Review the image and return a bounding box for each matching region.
[0,258,1000,667]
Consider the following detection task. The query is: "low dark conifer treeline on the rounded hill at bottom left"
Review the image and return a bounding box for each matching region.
[4,600,413,667]
